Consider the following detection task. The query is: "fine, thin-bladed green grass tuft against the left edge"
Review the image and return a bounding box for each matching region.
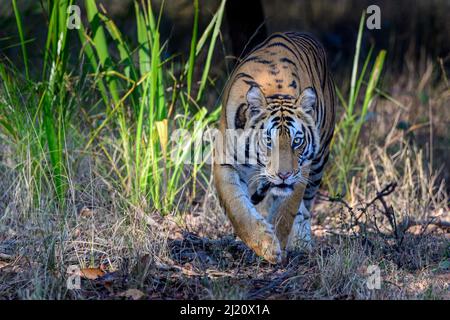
[0,62,48,208]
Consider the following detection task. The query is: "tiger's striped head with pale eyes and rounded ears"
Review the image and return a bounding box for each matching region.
[239,86,320,196]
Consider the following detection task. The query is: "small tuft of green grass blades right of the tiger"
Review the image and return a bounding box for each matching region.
[325,12,386,195]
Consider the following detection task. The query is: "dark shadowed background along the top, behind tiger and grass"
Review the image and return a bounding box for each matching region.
[0,0,450,75]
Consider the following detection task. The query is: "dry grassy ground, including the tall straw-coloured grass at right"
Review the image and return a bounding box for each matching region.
[0,40,450,299]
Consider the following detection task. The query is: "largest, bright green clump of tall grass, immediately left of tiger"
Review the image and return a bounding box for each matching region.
[80,0,225,212]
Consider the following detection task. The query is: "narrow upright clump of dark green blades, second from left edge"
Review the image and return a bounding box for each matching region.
[7,0,72,204]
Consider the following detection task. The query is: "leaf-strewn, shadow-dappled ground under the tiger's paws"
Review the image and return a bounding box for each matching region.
[0,166,450,299]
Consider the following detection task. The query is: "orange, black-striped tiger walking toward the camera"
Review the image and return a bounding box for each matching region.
[212,32,336,264]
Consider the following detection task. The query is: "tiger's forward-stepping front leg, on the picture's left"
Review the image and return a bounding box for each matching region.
[214,164,281,263]
